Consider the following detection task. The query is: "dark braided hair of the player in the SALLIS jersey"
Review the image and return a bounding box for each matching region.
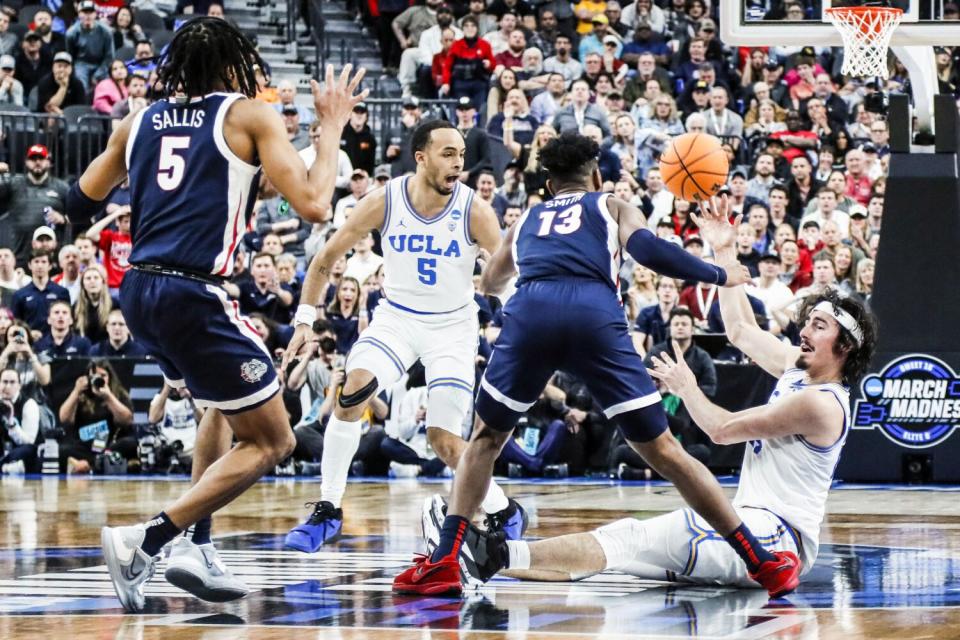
[157,16,264,98]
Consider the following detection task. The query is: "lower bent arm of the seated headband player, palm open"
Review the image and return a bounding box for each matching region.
[649,341,844,446]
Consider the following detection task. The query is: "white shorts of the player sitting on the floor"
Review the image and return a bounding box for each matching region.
[591,507,811,587]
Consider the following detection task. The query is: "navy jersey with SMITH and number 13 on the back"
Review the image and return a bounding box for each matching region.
[513,192,620,295]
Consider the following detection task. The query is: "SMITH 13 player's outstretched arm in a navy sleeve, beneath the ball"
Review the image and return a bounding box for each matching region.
[607,197,750,287]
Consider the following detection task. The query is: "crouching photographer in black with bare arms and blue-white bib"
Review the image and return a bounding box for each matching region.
[60,360,139,473]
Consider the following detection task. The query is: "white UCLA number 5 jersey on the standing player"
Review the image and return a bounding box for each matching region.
[380,176,479,313]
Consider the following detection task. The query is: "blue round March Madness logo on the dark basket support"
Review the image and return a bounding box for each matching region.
[853,354,960,449]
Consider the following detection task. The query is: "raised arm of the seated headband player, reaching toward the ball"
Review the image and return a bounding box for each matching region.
[694,197,800,378]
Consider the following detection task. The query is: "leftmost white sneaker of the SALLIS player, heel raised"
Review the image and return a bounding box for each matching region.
[100,524,158,613]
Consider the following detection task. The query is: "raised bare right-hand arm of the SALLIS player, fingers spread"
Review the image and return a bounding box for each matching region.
[244,64,369,222]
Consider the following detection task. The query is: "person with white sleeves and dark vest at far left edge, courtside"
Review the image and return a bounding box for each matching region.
[0,369,40,474]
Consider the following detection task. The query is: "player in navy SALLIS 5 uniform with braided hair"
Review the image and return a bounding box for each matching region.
[67,17,366,611]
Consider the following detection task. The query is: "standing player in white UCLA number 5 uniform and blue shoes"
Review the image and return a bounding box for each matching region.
[284,121,525,552]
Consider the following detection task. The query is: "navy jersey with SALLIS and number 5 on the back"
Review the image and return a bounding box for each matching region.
[126,93,260,277]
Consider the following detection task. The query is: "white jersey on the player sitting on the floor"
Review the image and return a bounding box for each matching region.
[733,369,850,568]
